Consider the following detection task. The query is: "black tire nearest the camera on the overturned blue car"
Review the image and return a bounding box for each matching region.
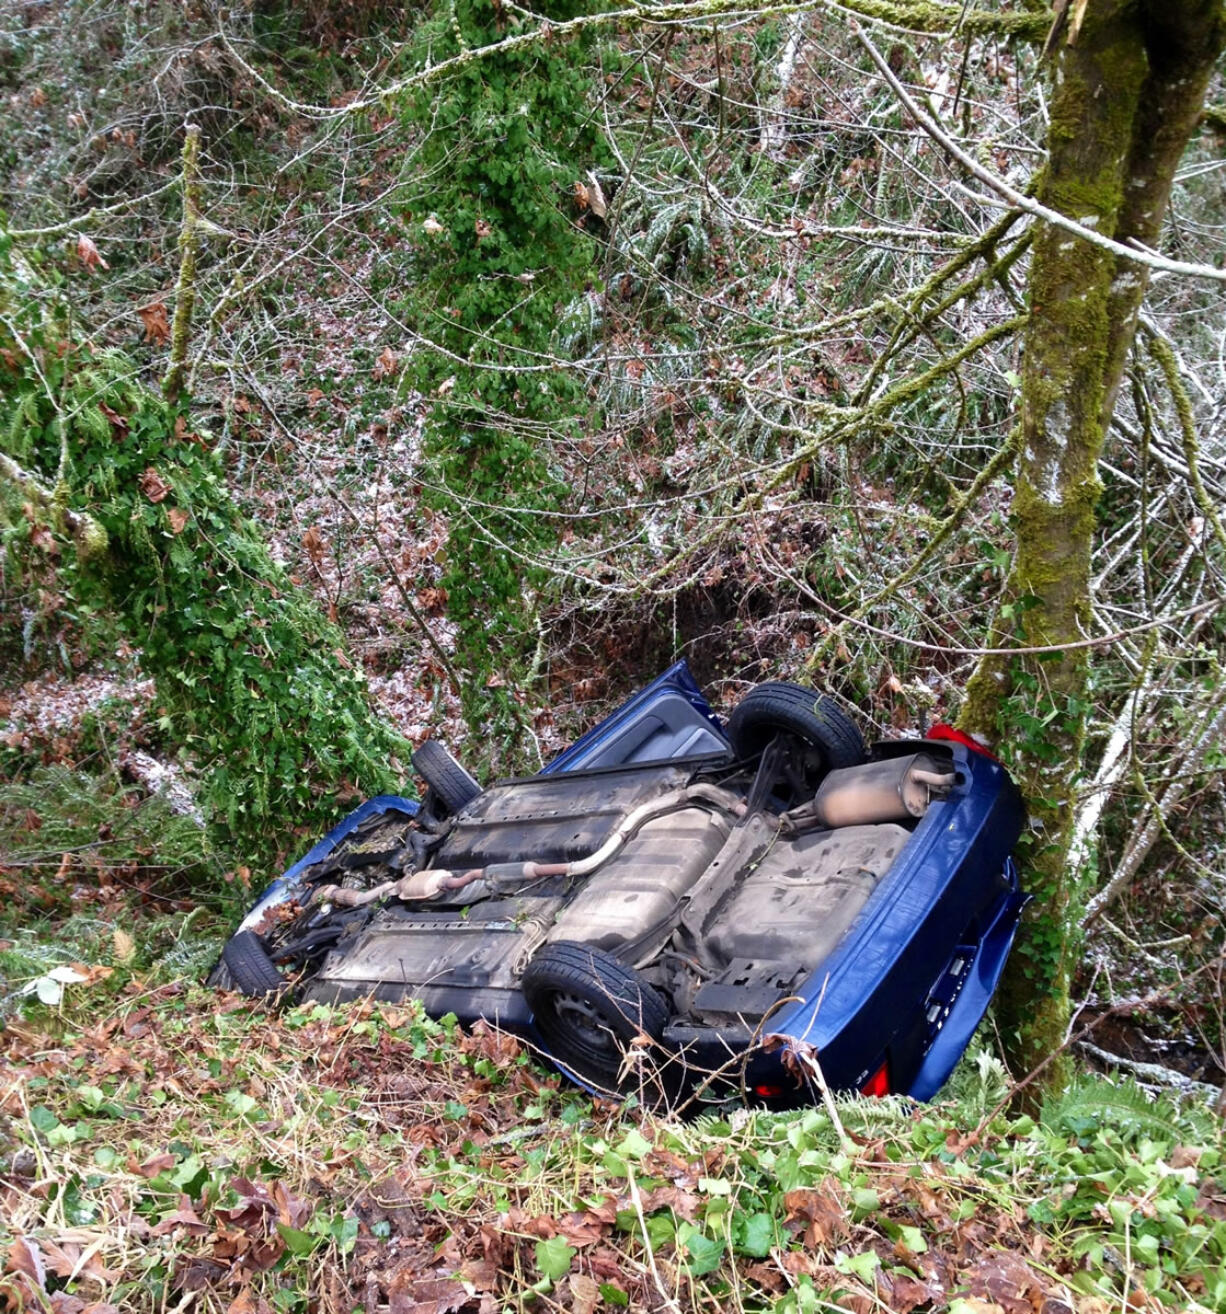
[520,940,669,1091]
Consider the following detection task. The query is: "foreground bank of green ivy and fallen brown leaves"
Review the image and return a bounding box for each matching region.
[0,941,1226,1314]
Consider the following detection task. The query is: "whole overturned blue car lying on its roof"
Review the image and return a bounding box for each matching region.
[210,662,1026,1108]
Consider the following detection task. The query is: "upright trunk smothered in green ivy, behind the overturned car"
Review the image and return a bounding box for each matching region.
[391,0,601,671]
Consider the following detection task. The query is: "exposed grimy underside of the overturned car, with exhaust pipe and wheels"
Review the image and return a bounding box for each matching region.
[212,686,1020,1093]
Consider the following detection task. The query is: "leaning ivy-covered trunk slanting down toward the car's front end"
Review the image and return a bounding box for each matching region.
[0,242,407,858]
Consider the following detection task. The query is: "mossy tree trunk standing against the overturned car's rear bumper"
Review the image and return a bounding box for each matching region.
[962,0,1226,1088]
